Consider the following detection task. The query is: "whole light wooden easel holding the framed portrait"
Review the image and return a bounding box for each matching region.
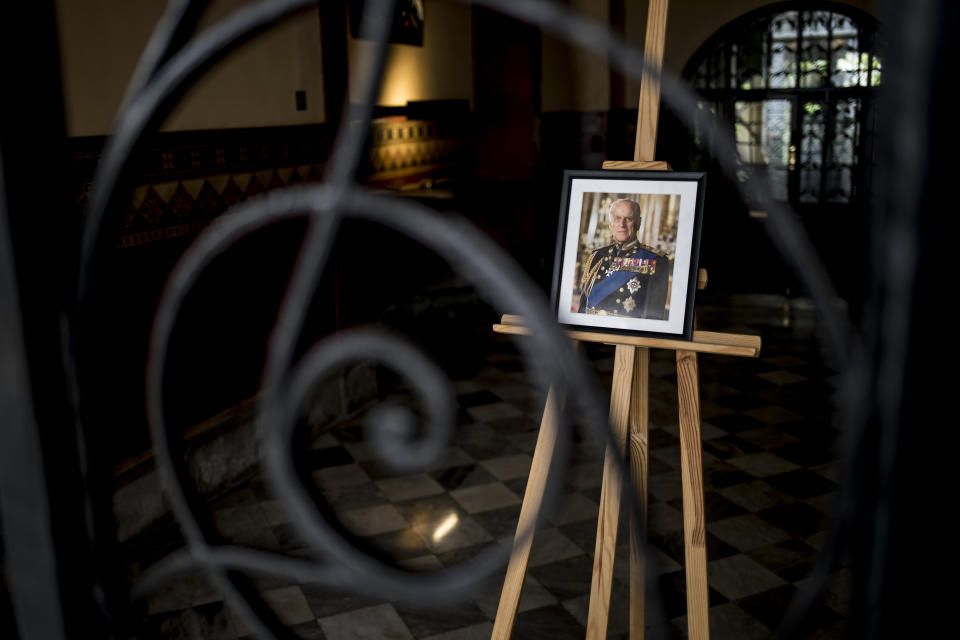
[491,0,760,640]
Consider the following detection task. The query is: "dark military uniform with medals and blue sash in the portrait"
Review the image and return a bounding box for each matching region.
[578,239,670,320]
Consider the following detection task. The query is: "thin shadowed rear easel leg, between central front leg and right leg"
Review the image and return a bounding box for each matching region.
[628,347,650,640]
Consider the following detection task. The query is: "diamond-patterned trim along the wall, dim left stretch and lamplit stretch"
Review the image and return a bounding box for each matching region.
[69,117,473,248]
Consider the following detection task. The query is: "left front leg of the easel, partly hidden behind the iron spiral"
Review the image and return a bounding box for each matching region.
[490,387,560,640]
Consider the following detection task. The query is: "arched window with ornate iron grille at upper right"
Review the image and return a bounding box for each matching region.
[684,2,883,208]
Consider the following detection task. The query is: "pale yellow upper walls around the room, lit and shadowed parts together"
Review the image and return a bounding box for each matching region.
[56,0,871,131]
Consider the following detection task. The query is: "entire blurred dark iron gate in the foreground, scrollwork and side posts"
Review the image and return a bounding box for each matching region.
[0,0,944,640]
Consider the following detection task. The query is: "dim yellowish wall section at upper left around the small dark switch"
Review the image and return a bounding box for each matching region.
[56,0,325,136]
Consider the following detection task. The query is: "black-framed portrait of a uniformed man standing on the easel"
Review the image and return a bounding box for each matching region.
[553,171,706,340]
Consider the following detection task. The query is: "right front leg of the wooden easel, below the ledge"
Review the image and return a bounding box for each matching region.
[677,351,710,640]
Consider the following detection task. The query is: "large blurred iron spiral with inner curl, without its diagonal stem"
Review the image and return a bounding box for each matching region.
[135,186,603,632]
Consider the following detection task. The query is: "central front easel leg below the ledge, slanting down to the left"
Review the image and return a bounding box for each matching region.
[587,345,636,640]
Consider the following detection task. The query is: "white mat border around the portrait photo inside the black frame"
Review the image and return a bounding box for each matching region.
[557,178,697,335]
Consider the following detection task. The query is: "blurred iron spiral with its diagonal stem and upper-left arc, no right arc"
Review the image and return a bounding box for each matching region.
[73,1,604,635]
